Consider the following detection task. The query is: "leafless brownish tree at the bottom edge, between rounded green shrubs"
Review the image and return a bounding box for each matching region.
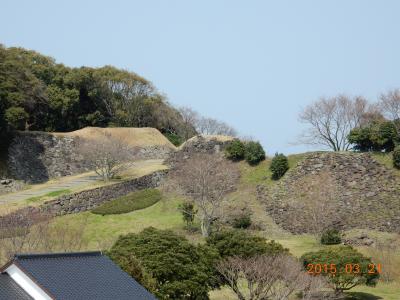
[217,255,325,300]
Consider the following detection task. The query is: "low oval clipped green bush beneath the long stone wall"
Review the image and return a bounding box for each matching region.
[92,189,162,216]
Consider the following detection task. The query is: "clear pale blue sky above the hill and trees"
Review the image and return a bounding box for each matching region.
[0,0,400,155]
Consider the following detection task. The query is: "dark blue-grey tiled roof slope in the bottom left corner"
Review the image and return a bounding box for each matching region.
[13,252,156,300]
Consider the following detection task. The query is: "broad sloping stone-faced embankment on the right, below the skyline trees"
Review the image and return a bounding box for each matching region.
[257,153,400,233]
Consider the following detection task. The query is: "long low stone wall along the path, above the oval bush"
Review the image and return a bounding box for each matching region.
[40,171,166,216]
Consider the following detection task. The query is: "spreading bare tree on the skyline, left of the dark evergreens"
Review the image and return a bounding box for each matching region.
[299,95,369,151]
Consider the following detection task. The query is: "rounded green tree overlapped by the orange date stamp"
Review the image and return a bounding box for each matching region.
[301,246,379,294]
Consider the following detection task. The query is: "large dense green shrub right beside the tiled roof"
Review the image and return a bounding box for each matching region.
[109,228,219,299]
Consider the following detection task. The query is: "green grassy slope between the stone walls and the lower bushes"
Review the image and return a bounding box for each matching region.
[9,154,400,300]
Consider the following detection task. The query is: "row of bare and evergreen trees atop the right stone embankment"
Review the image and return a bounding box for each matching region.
[299,89,400,152]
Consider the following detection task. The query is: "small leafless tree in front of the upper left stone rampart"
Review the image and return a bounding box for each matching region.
[78,132,133,181]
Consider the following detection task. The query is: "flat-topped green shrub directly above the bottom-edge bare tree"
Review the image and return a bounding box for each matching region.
[207,229,289,258]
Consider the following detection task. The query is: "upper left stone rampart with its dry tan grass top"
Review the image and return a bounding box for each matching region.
[8,127,176,183]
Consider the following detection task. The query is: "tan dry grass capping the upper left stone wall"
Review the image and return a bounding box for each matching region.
[52,127,176,149]
